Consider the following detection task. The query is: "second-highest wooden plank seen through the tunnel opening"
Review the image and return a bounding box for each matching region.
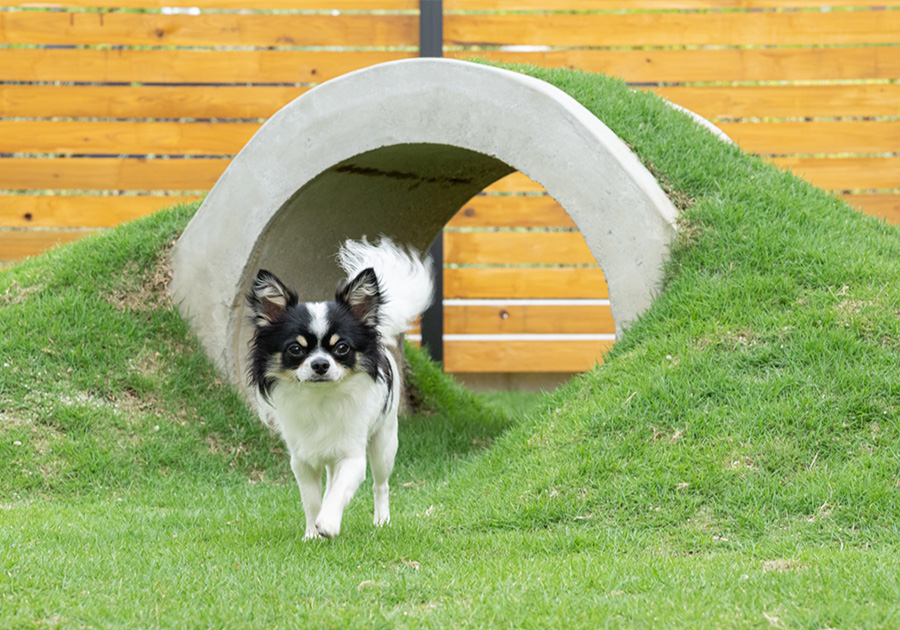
[447,195,576,228]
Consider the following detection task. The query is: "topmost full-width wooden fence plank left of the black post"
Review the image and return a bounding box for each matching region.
[0,11,419,48]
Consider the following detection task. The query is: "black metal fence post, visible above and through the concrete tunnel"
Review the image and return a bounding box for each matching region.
[419,0,444,363]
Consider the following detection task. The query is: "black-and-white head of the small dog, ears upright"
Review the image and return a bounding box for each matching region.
[247,269,383,396]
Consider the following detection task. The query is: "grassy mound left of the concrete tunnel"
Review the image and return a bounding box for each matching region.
[0,207,276,496]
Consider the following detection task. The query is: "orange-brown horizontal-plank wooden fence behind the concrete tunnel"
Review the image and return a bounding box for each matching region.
[0,0,900,372]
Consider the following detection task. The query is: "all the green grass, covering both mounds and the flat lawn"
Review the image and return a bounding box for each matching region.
[0,68,900,628]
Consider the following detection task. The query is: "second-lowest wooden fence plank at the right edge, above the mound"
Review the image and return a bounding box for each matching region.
[770,157,900,190]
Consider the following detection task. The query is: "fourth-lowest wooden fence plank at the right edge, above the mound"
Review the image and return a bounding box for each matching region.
[648,83,900,121]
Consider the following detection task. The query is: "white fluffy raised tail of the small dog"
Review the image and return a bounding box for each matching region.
[338,236,434,346]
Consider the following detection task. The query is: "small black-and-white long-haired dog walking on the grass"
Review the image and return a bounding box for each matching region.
[247,237,433,540]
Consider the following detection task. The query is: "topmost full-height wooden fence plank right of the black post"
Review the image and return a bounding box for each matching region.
[444,11,900,47]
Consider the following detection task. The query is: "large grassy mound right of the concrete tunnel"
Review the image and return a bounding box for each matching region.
[446,61,900,551]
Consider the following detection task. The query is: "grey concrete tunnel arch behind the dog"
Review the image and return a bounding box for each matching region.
[171,59,677,382]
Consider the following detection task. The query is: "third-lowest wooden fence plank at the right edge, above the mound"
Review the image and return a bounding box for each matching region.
[717,120,900,155]
